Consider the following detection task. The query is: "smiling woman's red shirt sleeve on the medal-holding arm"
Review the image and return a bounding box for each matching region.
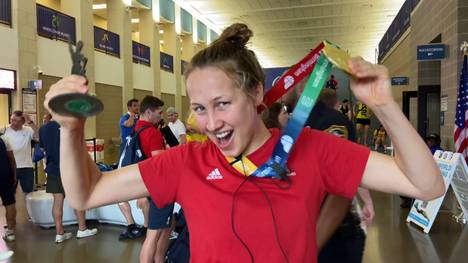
[309,130,370,199]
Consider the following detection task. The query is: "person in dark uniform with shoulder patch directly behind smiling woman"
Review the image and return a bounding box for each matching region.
[285,87,375,263]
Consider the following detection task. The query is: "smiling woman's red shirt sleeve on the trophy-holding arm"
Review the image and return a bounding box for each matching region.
[138,145,186,208]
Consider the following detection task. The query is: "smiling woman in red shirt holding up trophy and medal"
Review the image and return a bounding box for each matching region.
[45,24,444,262]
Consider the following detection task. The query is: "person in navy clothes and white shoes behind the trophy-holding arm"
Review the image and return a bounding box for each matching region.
[39,116,97,244]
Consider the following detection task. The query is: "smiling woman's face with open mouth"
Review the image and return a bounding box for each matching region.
[187,67,263,156]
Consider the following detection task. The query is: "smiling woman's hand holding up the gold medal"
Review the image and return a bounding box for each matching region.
[348,57,393,110]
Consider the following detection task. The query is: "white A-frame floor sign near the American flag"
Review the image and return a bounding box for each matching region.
[406,151,468,233]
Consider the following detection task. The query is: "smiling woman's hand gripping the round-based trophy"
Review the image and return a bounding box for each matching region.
[44,75,88,130]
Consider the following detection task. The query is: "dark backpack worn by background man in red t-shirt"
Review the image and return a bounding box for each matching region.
[117,126,151,168]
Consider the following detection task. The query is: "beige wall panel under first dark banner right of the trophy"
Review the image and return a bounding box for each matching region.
[94,51,124,87]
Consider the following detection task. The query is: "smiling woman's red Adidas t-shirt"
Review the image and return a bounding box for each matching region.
[139,128,369,263]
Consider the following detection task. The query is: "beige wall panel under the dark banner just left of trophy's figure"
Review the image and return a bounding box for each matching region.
[36,36,72,77]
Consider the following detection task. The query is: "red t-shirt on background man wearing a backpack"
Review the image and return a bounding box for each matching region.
[135,120,165,158]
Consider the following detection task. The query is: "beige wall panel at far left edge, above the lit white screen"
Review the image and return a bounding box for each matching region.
[0,25,18,70]
